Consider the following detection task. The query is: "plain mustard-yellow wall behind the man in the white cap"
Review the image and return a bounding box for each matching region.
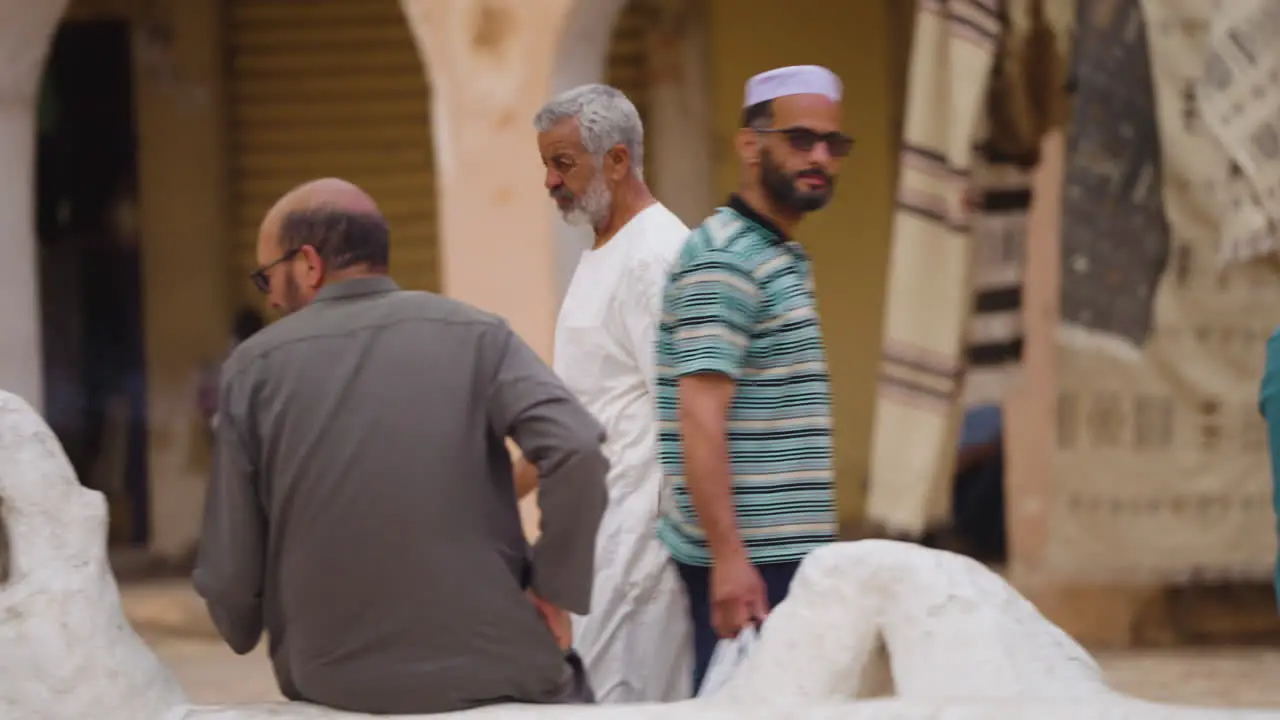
[709,0,900,523]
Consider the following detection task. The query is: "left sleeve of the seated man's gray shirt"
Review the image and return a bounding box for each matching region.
[192,366,266,655]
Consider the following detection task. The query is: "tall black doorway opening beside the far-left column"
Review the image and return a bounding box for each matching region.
[35,12,150,546]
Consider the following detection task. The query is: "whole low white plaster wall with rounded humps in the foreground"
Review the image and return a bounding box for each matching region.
[0,391,1280,720]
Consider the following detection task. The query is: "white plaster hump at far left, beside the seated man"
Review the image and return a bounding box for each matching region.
[0,392,187,720]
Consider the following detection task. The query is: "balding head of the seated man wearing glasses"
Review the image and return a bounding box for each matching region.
[255,178,390,311]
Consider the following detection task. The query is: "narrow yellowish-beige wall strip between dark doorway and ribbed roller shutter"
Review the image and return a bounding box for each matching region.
[134,0,232,555]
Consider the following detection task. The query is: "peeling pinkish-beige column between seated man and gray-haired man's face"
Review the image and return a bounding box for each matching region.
[401,0,573,359]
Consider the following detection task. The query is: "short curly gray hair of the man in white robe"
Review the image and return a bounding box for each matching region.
[534,83,644,179]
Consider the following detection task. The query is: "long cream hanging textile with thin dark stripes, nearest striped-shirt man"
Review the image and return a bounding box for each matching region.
[867,0,1002,536]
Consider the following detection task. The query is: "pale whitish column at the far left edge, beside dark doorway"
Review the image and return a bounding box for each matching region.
[0,0,67,410]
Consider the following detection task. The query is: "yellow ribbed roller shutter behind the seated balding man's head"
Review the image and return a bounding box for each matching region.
[227,0,438,304]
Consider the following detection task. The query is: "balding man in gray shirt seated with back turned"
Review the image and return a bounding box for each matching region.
[193,179,608,714]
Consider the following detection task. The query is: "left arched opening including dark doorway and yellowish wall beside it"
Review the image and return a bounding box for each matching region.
[30,0,243,561]
